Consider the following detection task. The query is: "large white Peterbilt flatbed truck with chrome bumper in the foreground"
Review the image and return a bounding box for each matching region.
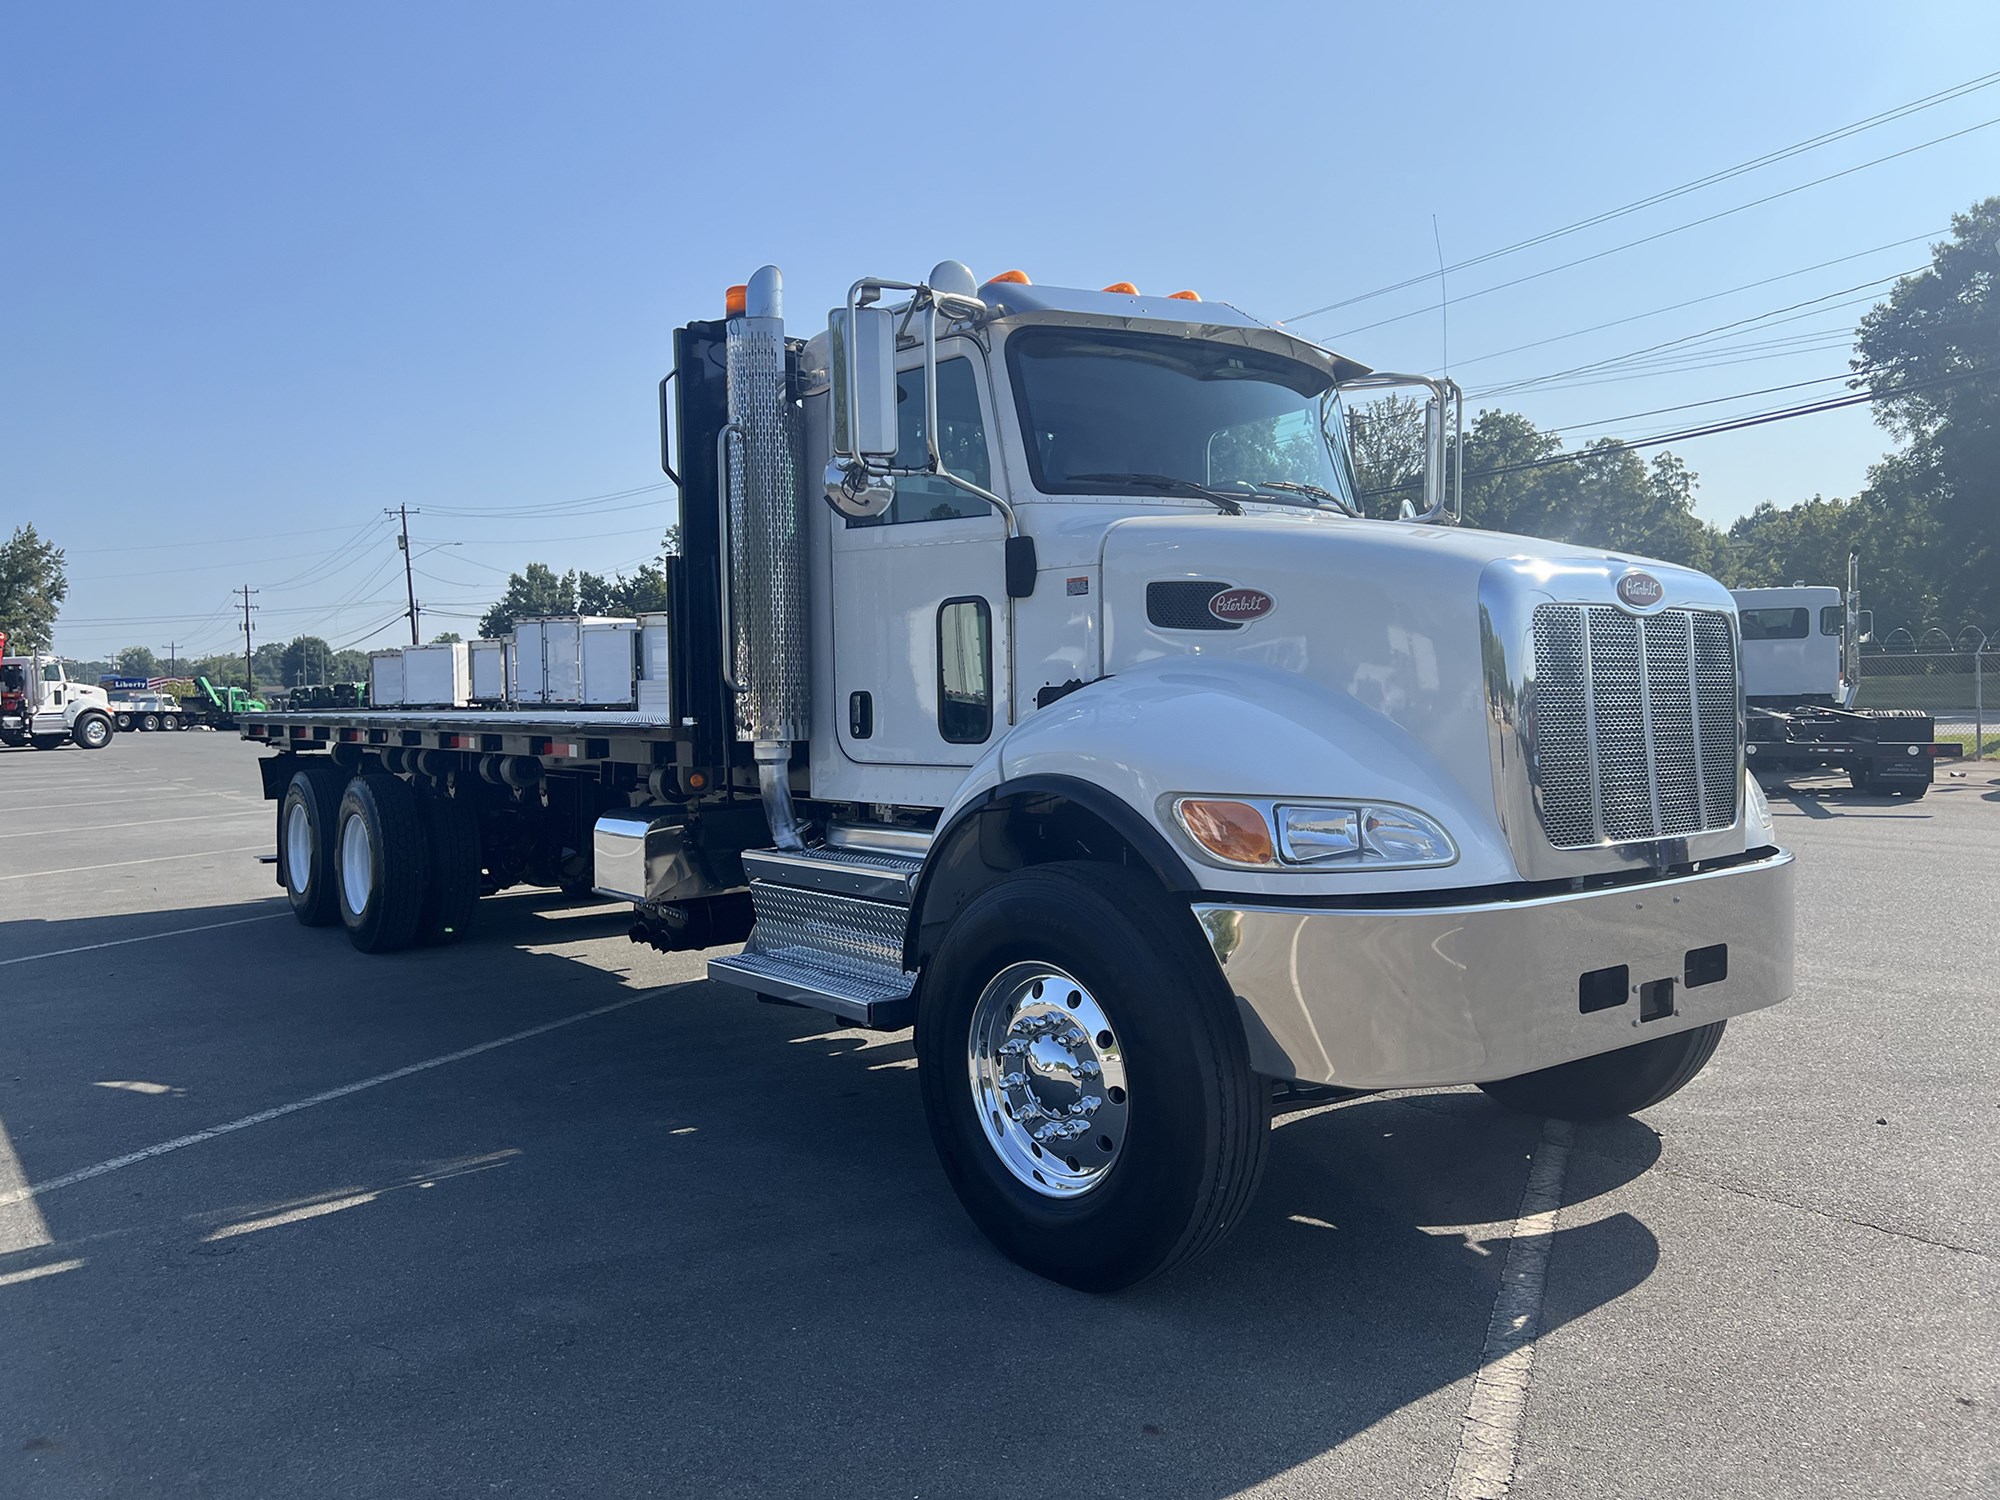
[242,262,1792,1290]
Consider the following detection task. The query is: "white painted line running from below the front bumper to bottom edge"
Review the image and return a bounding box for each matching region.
[1448,1120,1570,1500]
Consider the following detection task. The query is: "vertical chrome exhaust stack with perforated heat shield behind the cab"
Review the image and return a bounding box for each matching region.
[718,266,812,848]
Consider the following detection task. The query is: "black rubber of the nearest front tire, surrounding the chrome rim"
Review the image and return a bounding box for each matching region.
[916,864,1270,1292]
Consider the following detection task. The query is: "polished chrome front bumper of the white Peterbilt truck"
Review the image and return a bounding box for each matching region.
[1194,850,1792,1088]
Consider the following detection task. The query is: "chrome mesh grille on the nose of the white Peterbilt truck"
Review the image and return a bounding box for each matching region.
[1532,604,1740,848]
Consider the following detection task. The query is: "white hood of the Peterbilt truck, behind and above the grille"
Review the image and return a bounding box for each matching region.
[1102,514,1732,828]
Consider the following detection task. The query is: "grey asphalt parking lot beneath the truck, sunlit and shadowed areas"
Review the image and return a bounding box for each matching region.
[0,734,2000,1500]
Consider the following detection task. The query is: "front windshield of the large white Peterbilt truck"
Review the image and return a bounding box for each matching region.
[1006,328,1354,506]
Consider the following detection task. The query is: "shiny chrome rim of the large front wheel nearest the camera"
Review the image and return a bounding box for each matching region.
[966,964,1130,1198]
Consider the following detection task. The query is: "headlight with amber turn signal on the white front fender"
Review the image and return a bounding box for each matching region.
[1174,796,1458,870]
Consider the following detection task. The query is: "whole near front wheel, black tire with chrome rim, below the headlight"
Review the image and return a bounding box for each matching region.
[916,864,1270,1292]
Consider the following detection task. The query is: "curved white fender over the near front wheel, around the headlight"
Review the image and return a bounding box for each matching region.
[938,656,1520,896]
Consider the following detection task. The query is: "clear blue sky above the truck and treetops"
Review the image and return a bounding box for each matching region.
[0,0,2000,656]
